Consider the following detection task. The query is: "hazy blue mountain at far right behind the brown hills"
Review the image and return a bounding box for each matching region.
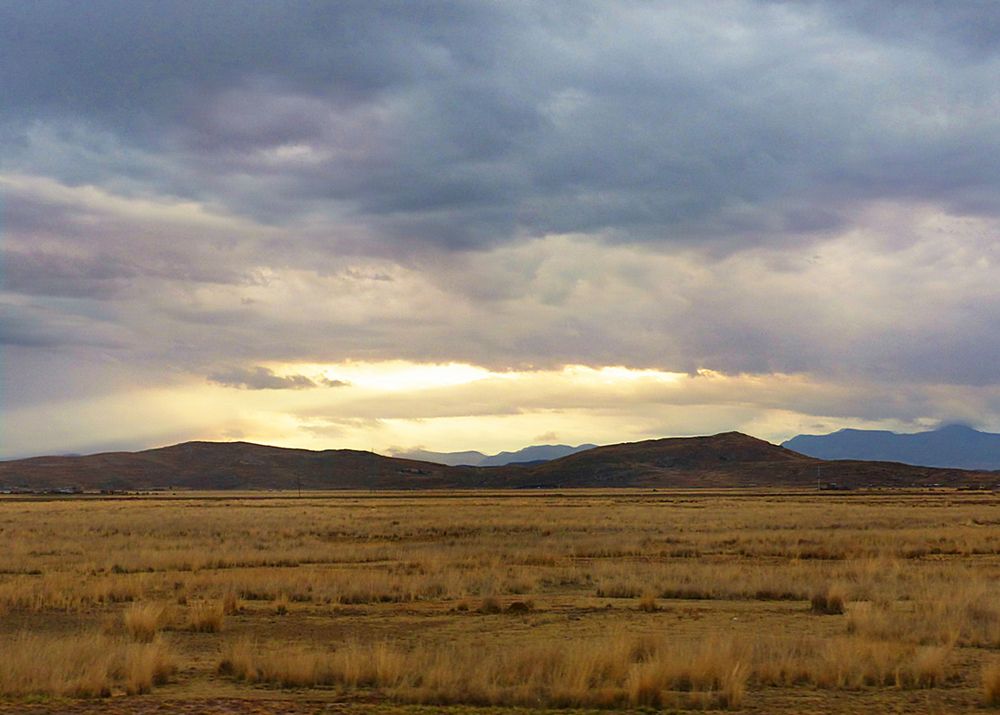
[781,425,1000,470]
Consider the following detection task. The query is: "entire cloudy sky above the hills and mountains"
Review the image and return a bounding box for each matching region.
[0,0,1000,458]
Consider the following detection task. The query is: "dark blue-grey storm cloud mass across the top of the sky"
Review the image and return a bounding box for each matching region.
[0,2,1000,251]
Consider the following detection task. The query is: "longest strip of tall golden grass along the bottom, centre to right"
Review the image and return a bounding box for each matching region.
[218,634,951,707]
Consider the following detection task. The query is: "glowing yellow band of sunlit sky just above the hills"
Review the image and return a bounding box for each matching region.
[7,360,932,456]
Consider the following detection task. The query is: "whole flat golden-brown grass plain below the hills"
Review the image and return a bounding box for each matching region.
[0,490,1000,714]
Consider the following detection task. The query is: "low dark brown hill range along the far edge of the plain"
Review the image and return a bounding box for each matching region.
[0,432,1000,490]
